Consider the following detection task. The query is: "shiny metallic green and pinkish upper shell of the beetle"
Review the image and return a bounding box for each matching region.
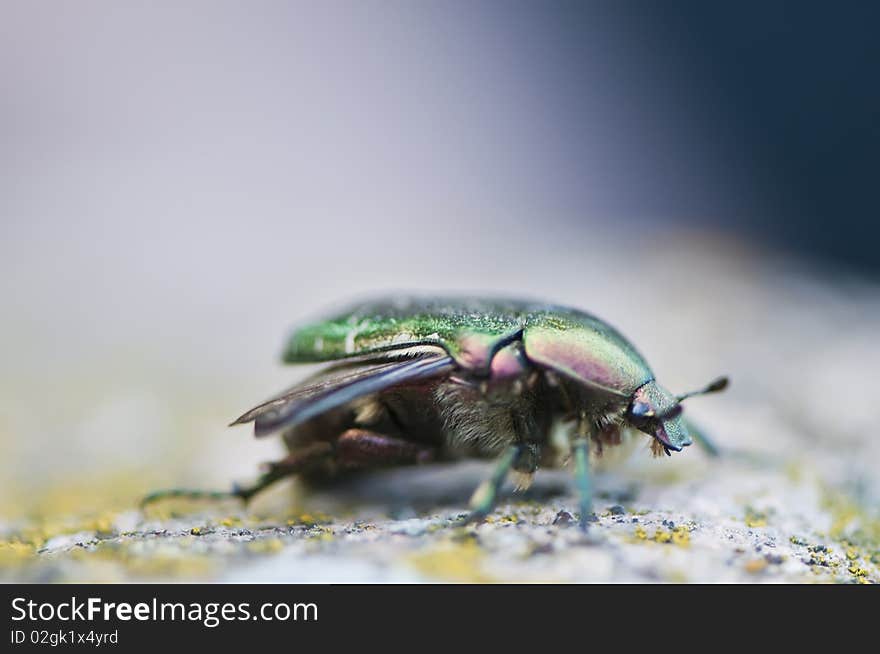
[284,298,653,396]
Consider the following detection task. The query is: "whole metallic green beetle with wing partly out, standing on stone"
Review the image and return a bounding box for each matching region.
[145,297,728,527]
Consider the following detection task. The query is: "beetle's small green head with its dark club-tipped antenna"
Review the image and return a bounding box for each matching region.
[626,377,728,454]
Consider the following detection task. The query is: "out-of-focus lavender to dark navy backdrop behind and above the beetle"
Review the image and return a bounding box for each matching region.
[0,0,880,515]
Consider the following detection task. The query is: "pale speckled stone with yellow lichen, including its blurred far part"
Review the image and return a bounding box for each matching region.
[0,240,880,583]
